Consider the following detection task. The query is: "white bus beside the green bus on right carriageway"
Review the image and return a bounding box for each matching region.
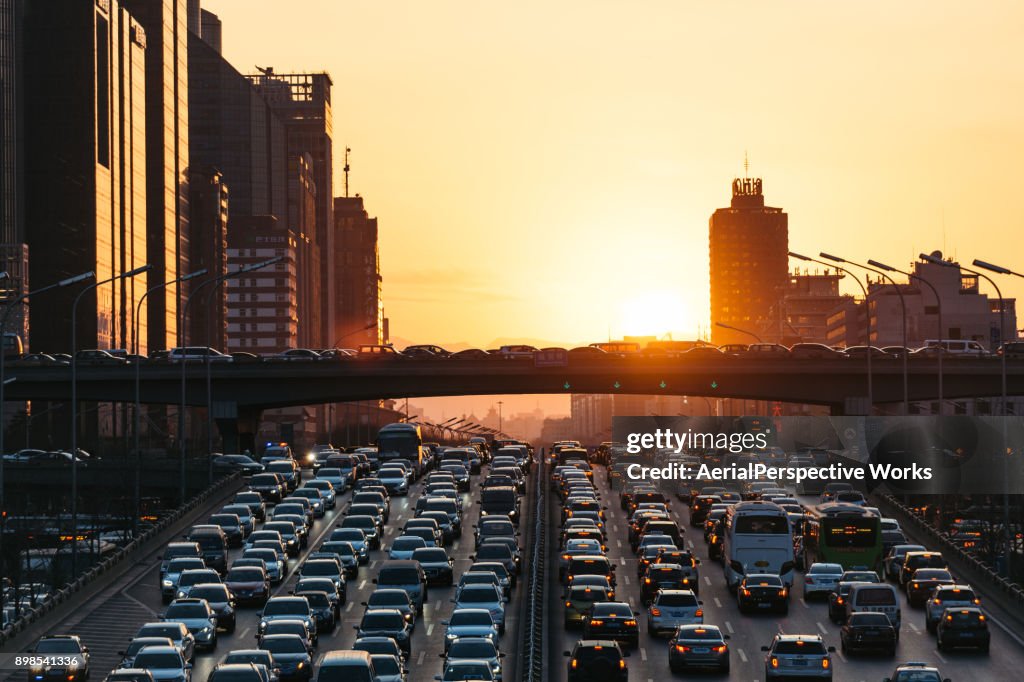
[722,500,796,590]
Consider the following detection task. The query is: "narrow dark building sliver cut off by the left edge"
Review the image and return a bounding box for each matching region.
[0,0,29,343]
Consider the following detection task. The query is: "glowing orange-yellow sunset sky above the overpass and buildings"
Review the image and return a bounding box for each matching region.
[203,0,1024,346]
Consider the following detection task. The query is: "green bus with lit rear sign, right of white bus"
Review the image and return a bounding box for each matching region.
[803,502,883,576]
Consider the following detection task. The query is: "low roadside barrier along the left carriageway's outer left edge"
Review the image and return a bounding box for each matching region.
[0,471,242,646]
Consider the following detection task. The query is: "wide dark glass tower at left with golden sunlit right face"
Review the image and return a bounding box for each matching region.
[25,0,149,352]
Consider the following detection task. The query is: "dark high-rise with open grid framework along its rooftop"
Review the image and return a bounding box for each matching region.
[249,68,337,346]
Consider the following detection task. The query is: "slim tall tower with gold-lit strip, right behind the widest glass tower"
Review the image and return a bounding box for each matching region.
[122,0,189,348]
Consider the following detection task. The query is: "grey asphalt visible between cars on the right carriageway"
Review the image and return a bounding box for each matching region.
[546,466,1024,682]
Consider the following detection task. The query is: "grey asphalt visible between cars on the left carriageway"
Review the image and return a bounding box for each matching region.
[18,458,534,682]
